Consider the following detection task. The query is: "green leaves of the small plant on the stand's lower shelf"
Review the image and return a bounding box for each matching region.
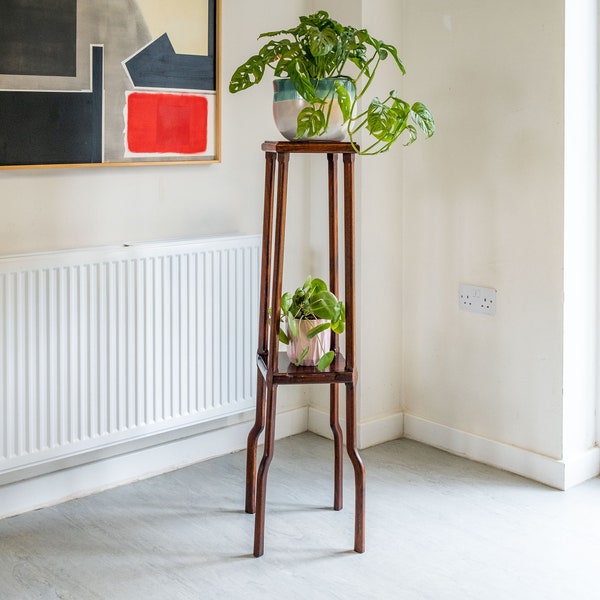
[279,275,346,371]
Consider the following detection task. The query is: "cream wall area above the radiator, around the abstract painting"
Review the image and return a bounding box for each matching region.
[0,0,304,254]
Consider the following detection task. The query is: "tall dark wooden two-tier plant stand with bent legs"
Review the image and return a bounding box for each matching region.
[246,142,365,556]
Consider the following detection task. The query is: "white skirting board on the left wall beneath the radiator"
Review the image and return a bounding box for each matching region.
[0,407,308,518]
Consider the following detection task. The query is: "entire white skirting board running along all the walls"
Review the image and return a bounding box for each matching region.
[0,407,600,518]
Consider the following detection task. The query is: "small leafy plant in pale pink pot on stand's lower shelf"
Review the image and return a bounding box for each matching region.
[279,275,346,371]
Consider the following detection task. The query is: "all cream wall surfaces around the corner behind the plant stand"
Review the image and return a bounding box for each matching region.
[0,0,597,496]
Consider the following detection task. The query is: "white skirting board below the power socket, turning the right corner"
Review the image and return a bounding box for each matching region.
[404,414,600,490]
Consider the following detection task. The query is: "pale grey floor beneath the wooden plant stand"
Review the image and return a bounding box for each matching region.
[0,434,600,600]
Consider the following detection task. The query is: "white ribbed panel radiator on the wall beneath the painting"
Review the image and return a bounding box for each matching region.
[0,236,260,483]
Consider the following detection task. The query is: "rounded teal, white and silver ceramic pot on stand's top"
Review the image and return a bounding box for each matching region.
[273,77,356,142]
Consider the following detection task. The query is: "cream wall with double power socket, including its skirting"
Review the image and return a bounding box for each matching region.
[402,0,598,487]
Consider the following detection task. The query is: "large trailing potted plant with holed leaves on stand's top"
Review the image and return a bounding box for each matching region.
[229,10,435,154]
